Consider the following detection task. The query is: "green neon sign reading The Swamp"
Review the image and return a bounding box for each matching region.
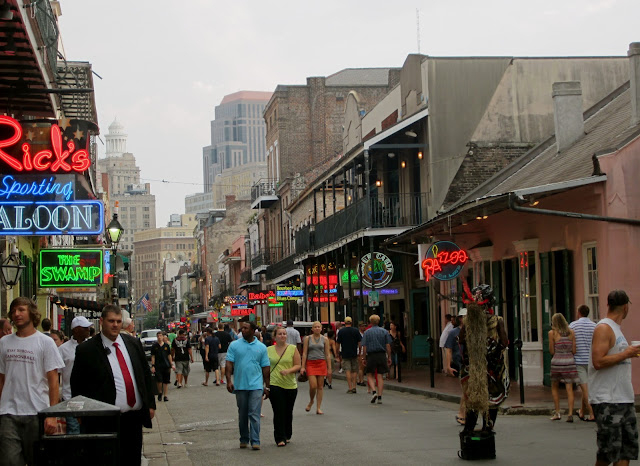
[38,249,103,288]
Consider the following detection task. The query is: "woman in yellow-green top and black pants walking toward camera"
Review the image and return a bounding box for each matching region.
[267,327,302,447]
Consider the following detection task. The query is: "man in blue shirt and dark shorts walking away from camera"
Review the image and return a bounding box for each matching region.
[362,314,392,404]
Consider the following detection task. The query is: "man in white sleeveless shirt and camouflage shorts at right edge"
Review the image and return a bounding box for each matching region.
[589,290,640,466]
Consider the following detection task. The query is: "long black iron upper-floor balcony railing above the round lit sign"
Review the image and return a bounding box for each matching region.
[295,193,427,254]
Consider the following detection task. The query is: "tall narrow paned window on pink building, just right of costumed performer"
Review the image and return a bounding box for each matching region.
[519,251,540,342]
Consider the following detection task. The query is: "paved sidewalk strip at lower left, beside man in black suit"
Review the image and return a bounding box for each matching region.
[142,396,193,466]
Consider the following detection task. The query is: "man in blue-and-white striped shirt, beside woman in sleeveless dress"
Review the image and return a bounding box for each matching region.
[569,304,596,422]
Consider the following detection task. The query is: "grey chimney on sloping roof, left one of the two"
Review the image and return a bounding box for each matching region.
[552,81,584,152]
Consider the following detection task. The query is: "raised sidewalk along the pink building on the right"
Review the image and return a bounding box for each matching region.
[333,366,556,416]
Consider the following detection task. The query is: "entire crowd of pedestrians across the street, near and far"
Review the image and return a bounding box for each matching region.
[0,285,640,465]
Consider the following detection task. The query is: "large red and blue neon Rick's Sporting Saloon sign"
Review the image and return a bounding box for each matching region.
[0,115,104,236]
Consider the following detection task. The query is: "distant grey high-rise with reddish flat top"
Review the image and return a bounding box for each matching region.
[202,91,272,208]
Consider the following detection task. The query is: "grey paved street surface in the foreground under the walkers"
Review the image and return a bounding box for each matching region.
[145,363,595,465]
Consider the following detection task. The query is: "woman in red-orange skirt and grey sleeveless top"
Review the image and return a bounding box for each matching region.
[300,321,331,414]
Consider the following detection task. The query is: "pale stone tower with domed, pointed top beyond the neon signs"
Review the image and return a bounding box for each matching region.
[98,119,156,250]
